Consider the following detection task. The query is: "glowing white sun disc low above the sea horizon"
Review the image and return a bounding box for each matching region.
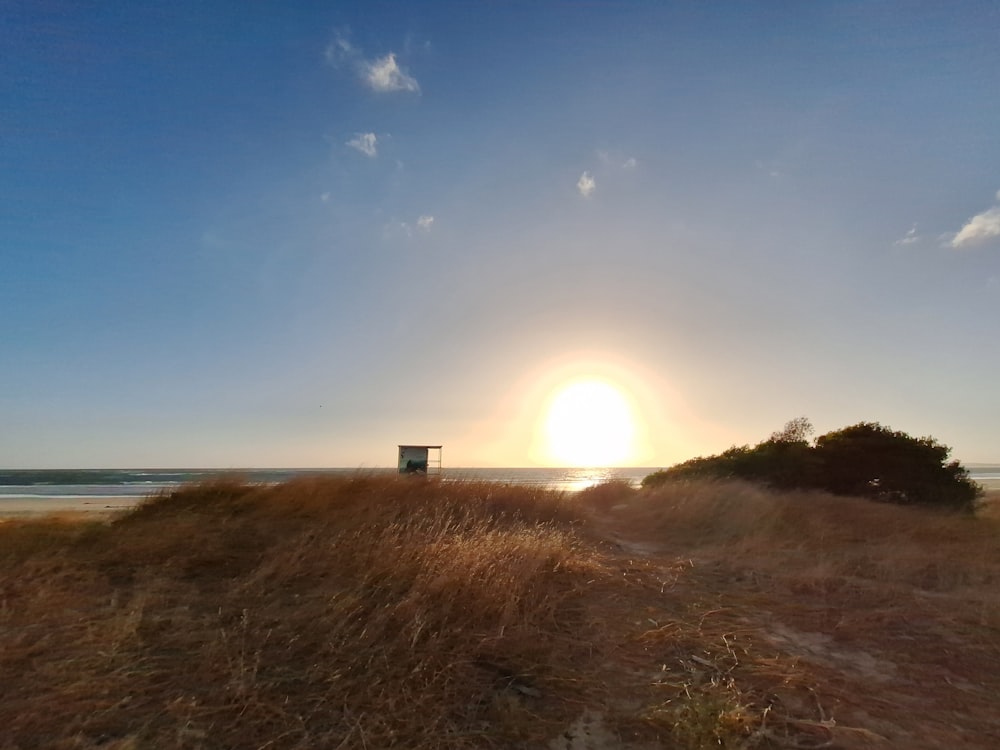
[542,378,636,467]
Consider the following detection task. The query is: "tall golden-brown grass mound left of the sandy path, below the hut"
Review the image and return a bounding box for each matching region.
[0,476,602,748]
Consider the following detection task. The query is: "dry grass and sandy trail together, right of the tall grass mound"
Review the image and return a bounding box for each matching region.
[580,482,1000,748]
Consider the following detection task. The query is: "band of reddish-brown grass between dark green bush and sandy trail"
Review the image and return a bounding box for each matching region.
[588,481,1000,604]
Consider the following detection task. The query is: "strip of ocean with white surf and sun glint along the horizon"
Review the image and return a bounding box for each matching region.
[0,464,1000,511]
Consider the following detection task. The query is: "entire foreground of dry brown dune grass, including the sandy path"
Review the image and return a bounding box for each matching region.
[0,475,1000,750]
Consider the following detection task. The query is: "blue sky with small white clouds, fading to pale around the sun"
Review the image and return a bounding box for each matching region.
[0,0,1000,468]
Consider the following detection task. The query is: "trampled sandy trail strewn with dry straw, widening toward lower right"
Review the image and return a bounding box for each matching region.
[572,509,1000,750]
